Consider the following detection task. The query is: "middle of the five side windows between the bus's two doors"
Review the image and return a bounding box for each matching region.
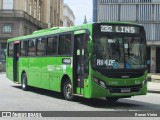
[37,38,46,56]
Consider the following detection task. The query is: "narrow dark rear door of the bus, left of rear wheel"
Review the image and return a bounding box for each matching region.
[13,41,20,82]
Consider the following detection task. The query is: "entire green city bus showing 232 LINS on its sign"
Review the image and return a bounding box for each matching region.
[6,22,147,102]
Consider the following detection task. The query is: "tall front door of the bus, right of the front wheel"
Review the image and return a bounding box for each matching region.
[73,30,89,94]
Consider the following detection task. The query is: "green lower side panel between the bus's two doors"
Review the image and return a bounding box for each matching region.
[18,57,72,92]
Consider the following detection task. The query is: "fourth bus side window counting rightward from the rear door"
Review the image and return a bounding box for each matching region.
[47,36,58,55]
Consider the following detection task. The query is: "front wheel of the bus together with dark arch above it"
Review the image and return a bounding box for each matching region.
[61,75,74,101]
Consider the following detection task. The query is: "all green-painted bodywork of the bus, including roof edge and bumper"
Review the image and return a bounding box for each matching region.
[6,22,147,98]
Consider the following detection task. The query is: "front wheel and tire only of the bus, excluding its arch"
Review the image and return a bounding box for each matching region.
[63,80,74,101]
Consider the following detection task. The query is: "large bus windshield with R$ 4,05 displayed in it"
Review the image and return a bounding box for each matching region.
[92,35,146,69]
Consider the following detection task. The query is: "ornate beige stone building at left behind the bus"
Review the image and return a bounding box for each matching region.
[0,0,63,71]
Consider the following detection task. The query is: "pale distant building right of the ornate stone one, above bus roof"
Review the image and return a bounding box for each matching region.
[63,4,75,27]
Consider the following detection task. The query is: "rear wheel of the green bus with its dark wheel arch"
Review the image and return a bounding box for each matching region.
[21,71,28,91]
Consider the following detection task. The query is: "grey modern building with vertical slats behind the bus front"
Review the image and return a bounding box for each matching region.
[93,0,160,73]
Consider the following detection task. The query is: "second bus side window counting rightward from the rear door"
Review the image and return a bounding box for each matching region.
[28,39,36,56]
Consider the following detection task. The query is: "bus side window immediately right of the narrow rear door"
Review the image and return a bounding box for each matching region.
[20,41,28,56]
